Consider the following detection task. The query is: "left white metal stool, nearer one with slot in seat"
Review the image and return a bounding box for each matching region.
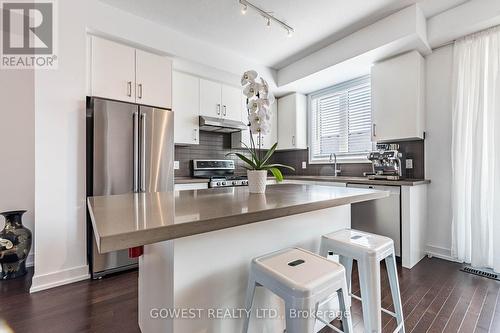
[243,248,353,333]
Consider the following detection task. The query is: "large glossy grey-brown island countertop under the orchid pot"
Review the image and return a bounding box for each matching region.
[87,184,389,253]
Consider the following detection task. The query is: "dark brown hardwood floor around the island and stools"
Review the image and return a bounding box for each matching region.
[0,258,500,333]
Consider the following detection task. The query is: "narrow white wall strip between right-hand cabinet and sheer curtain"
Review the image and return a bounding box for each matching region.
[425,45,453,259]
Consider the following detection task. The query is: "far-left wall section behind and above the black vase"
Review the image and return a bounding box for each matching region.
[0,70,35,265]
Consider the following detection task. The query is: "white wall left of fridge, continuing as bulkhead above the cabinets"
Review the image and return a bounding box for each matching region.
[31,0,275,292]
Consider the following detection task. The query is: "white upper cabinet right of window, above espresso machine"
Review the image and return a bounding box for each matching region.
[371,51,425,142]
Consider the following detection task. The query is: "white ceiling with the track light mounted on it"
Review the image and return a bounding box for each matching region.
[100,0,468,69]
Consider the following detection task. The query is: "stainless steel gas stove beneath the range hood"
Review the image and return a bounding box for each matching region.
[192,160,248,188]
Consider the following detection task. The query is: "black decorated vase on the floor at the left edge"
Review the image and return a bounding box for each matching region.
[0,210,32,280]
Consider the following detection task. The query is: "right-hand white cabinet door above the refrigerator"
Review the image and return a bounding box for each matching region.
[135,50,172,109]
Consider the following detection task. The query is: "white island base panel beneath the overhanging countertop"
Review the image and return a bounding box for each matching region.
[139,205,351,333]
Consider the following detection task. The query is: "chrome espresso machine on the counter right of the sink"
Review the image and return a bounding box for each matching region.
[365,144,403,180]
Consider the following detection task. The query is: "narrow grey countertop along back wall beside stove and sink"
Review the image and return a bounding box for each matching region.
[175,176,431,186]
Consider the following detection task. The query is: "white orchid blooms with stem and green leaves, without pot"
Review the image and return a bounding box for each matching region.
[230,71,295,182]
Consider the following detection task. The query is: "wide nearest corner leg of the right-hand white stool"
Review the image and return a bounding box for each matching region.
[358,258,382,333]
